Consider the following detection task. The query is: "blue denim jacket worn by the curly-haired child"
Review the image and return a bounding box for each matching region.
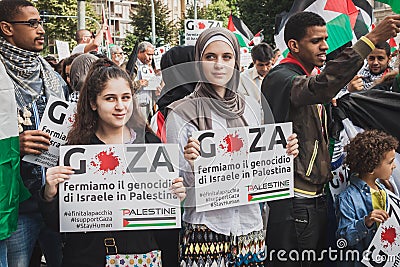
[336,174,388,264]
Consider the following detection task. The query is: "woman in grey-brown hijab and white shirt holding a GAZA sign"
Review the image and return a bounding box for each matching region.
[166,28,298,266]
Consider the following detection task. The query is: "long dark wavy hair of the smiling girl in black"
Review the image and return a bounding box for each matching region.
[68,58,147,145]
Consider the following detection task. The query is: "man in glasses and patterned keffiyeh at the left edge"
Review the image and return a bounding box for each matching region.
[0,0,67,267]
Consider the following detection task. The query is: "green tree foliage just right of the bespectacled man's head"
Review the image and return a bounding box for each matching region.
[35,0,101,54]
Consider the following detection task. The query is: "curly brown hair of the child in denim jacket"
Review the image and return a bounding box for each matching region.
[345,130,399,176]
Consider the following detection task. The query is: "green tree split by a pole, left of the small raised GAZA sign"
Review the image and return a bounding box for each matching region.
[123,0,177,51]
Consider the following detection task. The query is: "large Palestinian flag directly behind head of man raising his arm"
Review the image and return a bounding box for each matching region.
[275,0,373,56]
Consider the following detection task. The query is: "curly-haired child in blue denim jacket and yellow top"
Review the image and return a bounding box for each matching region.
[336,130,399,266]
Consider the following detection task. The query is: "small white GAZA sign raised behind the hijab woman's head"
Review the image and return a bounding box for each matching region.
[185,19,222,45]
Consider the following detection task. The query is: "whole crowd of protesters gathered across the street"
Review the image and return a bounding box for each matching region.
[0,0,400,267]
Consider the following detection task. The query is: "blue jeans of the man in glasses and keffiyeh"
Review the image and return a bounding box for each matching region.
[6,213,62,267]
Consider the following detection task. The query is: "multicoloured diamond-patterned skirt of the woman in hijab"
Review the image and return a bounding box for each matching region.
[180,223,266,267]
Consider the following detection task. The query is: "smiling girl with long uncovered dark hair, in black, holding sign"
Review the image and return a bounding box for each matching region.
[42,59,186,267]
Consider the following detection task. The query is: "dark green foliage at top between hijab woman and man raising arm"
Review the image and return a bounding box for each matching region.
[237,0,294,44]
